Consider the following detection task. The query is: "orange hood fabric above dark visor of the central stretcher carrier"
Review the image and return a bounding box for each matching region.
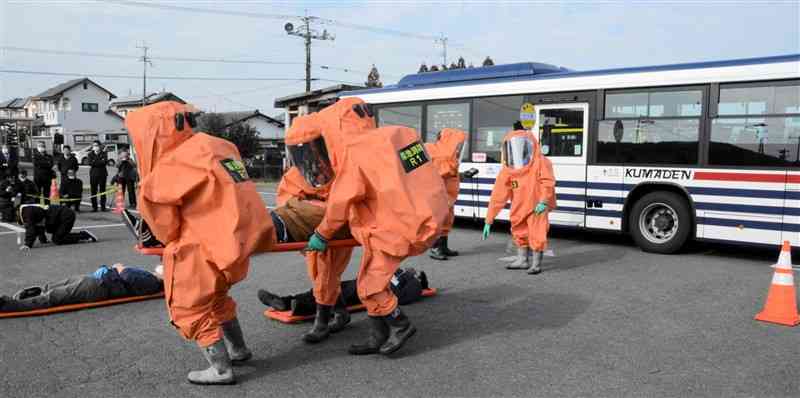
[285,98,376,172]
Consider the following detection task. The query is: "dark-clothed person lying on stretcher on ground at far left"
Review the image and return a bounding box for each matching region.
[0,263,164,312]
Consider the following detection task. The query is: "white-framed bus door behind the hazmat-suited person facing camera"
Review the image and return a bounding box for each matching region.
[533,103,589,227]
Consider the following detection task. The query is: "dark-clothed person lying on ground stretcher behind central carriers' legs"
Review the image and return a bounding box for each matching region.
[258,268,428,316]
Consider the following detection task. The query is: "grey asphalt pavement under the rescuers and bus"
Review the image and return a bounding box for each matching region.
[0,197,800,397]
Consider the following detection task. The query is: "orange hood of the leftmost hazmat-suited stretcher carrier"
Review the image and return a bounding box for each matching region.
[125,101,199,179]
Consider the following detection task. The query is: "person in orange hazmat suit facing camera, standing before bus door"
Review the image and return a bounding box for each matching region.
[483,130,556,274]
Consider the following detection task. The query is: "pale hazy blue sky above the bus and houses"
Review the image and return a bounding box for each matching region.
[0,0,800,115]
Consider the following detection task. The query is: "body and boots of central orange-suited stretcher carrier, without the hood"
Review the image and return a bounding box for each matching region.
[304,126,450,355]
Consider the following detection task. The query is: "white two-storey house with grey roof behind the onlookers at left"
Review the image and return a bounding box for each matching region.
[26,78,128,149]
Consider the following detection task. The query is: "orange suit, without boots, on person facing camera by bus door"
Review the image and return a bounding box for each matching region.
[486,130,556,252]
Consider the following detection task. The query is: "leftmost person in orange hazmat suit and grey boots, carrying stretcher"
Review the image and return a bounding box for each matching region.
[125,102,275,384]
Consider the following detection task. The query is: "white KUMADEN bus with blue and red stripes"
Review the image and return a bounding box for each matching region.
[343,54,800,253]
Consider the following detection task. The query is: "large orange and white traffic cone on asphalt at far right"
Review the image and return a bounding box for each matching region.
[756,240,800,326]
